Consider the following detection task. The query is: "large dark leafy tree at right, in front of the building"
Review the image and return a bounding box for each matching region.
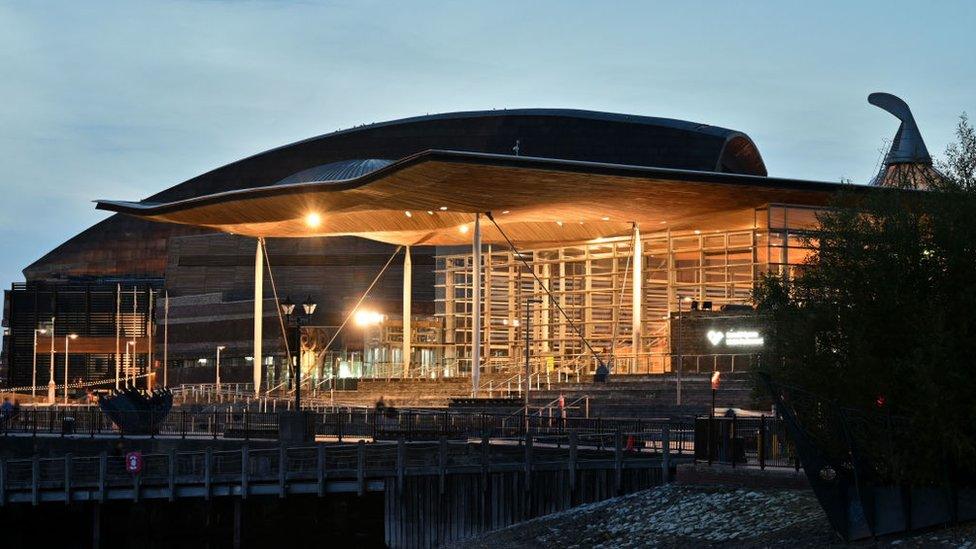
[755,115,976,479]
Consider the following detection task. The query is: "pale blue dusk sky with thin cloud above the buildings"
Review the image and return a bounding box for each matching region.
[0,0,976,287]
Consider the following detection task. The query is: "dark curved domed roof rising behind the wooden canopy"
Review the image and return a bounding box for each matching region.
[149,109,766,201]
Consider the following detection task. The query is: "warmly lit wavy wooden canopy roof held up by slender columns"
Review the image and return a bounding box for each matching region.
[97,150,865,245]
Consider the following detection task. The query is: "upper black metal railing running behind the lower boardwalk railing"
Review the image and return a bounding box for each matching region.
[0,407,695,456]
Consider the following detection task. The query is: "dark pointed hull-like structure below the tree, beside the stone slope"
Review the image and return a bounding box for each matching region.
[762,375,976,541]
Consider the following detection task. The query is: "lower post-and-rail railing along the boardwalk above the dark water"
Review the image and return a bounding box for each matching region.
[0,434,668,505]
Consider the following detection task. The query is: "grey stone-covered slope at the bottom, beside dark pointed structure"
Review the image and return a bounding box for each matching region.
[451,484,976,549]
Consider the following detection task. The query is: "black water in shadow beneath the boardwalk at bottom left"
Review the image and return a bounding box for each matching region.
[0,493,384,549]
